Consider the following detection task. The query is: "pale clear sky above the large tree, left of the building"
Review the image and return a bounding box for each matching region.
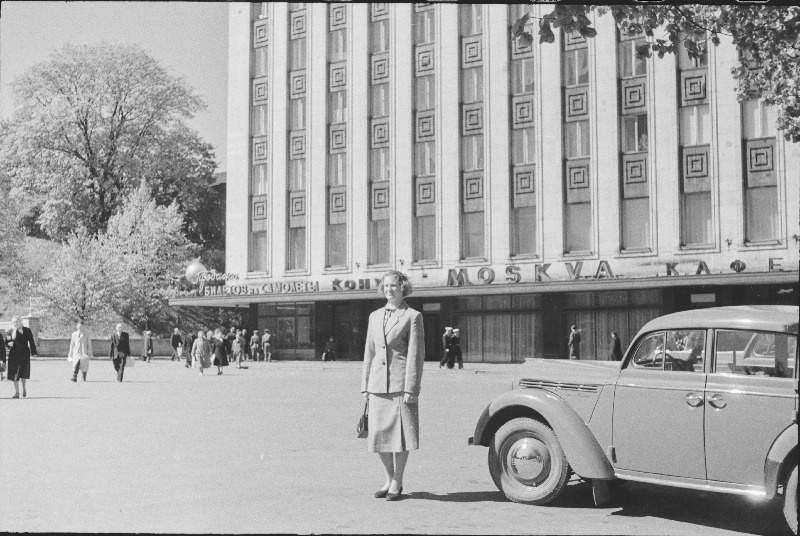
[0,0,228,171]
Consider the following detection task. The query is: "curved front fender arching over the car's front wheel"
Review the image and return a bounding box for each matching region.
[472,389,614,480]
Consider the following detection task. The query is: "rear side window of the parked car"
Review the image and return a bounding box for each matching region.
[714,330,797,378]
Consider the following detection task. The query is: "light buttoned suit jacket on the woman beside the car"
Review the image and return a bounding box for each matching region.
[361,304,425,396]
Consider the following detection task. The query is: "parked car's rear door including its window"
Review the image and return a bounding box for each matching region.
[705,330,797,487]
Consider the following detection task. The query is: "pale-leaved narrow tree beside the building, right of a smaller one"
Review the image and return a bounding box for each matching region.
[101,183,197,329]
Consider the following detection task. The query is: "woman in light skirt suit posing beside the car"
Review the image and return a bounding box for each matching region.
[361,270,425,501]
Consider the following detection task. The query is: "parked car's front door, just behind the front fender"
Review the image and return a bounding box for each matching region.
[612,331,706,480]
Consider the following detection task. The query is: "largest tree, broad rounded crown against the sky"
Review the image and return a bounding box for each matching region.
[0,43,216,239]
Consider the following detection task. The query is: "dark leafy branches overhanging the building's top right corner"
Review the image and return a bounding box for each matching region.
[512,4,800,142]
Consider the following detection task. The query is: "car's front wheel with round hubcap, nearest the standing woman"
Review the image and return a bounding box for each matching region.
[489,417,569,504]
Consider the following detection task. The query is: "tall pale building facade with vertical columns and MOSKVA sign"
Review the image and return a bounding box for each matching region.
[172,3,800,362]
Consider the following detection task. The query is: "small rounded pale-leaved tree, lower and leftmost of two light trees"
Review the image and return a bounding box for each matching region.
[37,229,119,323]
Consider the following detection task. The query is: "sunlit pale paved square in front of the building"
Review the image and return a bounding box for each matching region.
[0,360,784,535]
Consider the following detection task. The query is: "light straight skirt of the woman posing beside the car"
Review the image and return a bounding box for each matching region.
[367,393,419,452]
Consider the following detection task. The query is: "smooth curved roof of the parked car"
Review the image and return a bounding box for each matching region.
[639,305,800,333]
